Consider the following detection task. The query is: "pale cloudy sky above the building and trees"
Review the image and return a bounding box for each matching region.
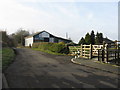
[0,0,118,43]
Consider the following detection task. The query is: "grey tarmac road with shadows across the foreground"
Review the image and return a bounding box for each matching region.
[4,48,118,88]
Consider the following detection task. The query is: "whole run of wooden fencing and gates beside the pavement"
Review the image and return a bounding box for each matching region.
[69,44,120,62]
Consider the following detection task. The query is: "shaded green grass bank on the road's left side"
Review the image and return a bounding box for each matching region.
[2,48,15,70]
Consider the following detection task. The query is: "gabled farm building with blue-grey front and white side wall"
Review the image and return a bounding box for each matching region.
[25,31,71,46]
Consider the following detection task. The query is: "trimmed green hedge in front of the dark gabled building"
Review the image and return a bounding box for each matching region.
[32,42,69,54]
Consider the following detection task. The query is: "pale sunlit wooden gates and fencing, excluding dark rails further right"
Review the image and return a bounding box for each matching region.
[69,44,103,59]
